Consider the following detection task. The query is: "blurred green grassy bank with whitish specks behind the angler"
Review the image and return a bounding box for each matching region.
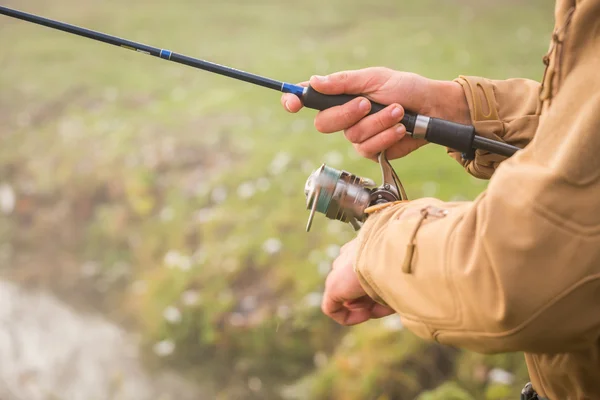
[0,0,552,398]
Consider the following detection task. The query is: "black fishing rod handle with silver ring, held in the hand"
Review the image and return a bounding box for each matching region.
[302,85,521,159]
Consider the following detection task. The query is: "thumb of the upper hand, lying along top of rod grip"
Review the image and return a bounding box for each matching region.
[309,67,391,94]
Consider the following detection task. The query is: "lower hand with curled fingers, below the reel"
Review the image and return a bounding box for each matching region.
[321,239,395,325]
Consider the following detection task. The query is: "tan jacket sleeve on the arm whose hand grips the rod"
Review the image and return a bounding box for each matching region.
[448,76,541,179]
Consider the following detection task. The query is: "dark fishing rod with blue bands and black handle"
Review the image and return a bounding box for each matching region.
[0,6,520,159]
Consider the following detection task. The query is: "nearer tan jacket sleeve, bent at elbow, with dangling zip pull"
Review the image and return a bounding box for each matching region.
[355,35,600,353]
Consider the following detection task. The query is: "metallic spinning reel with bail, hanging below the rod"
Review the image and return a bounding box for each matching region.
[304,152,408,232]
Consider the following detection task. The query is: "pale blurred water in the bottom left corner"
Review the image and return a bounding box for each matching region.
[0,280,214,400]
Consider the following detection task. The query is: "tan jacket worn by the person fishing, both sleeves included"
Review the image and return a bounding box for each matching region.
[355,0,600,400]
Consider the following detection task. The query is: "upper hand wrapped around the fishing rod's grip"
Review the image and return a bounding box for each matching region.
[281,67,469,161]
